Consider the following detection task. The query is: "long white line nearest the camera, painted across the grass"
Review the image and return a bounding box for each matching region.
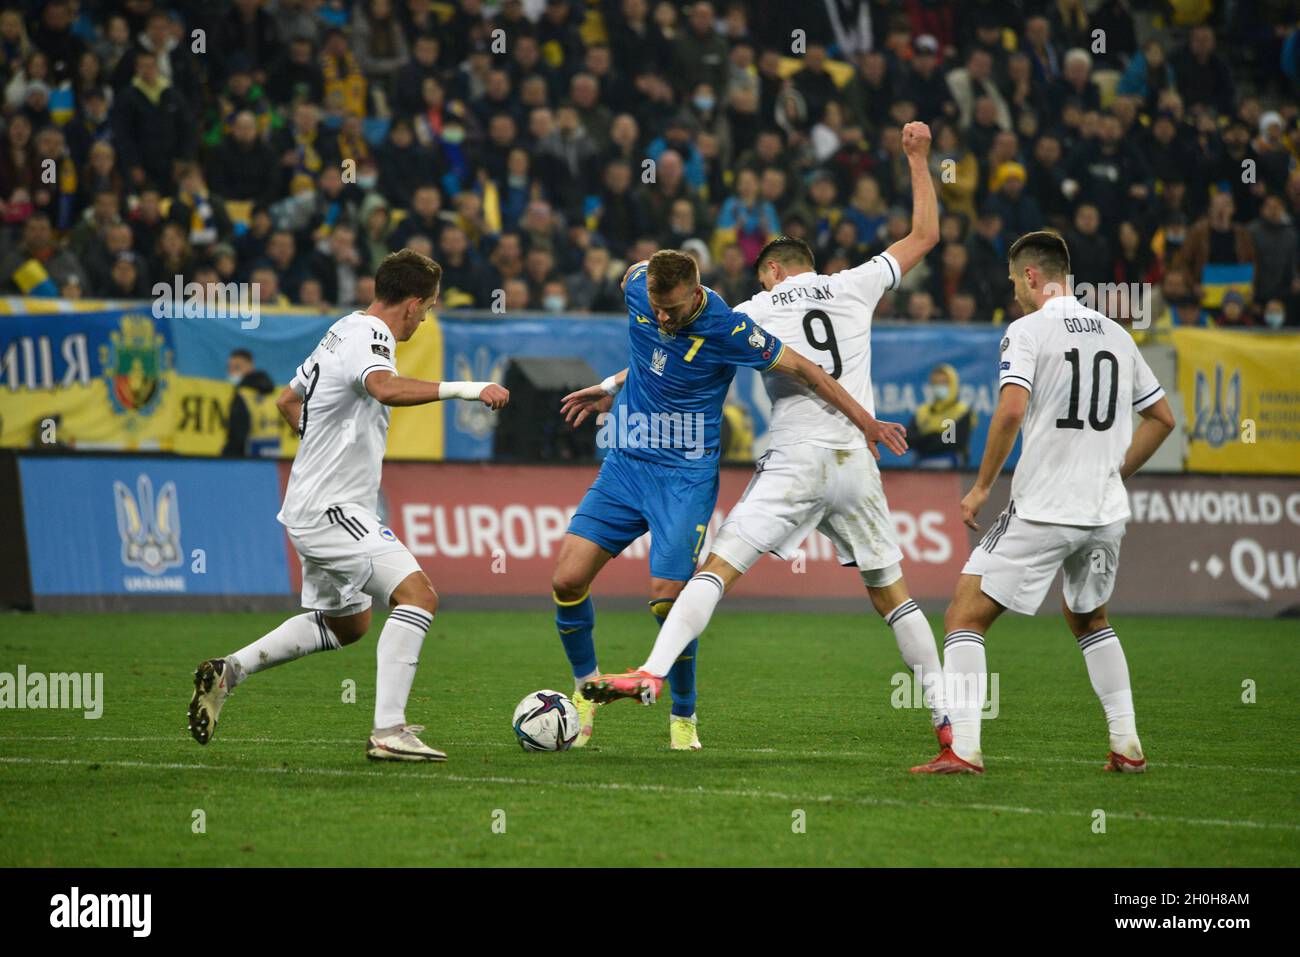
[0,757,1300,831]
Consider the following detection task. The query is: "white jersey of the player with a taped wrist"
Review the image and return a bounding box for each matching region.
[277,312,398,528]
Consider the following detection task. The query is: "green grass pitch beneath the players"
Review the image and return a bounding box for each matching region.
[0,606,1300,866]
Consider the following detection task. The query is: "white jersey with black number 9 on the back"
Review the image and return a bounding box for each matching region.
[735,252,902,449]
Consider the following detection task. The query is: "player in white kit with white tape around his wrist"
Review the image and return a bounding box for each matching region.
[189,250,510,761]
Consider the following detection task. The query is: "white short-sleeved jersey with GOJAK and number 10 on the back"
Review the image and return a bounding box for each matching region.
[998,295,1165,525]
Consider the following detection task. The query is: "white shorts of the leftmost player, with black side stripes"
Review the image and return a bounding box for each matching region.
[285,505,420,618]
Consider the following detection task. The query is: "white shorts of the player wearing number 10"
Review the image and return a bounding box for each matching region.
[962,502,1127,615]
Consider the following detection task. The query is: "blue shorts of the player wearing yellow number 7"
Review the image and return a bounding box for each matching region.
[568,451,718,581]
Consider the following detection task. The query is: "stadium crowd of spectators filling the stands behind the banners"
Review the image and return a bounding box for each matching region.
[0,0,1300,334]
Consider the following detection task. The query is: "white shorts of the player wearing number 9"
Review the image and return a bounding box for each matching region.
[712,445,902,588]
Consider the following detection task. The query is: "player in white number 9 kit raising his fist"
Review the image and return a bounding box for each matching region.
[584,122,952,764]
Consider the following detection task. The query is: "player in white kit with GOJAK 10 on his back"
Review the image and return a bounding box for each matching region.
[922,231,1174,774]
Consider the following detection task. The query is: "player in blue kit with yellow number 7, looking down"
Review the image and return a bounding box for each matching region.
[551,250,907,750]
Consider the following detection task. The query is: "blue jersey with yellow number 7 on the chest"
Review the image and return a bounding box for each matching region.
[601,264,785,468]
